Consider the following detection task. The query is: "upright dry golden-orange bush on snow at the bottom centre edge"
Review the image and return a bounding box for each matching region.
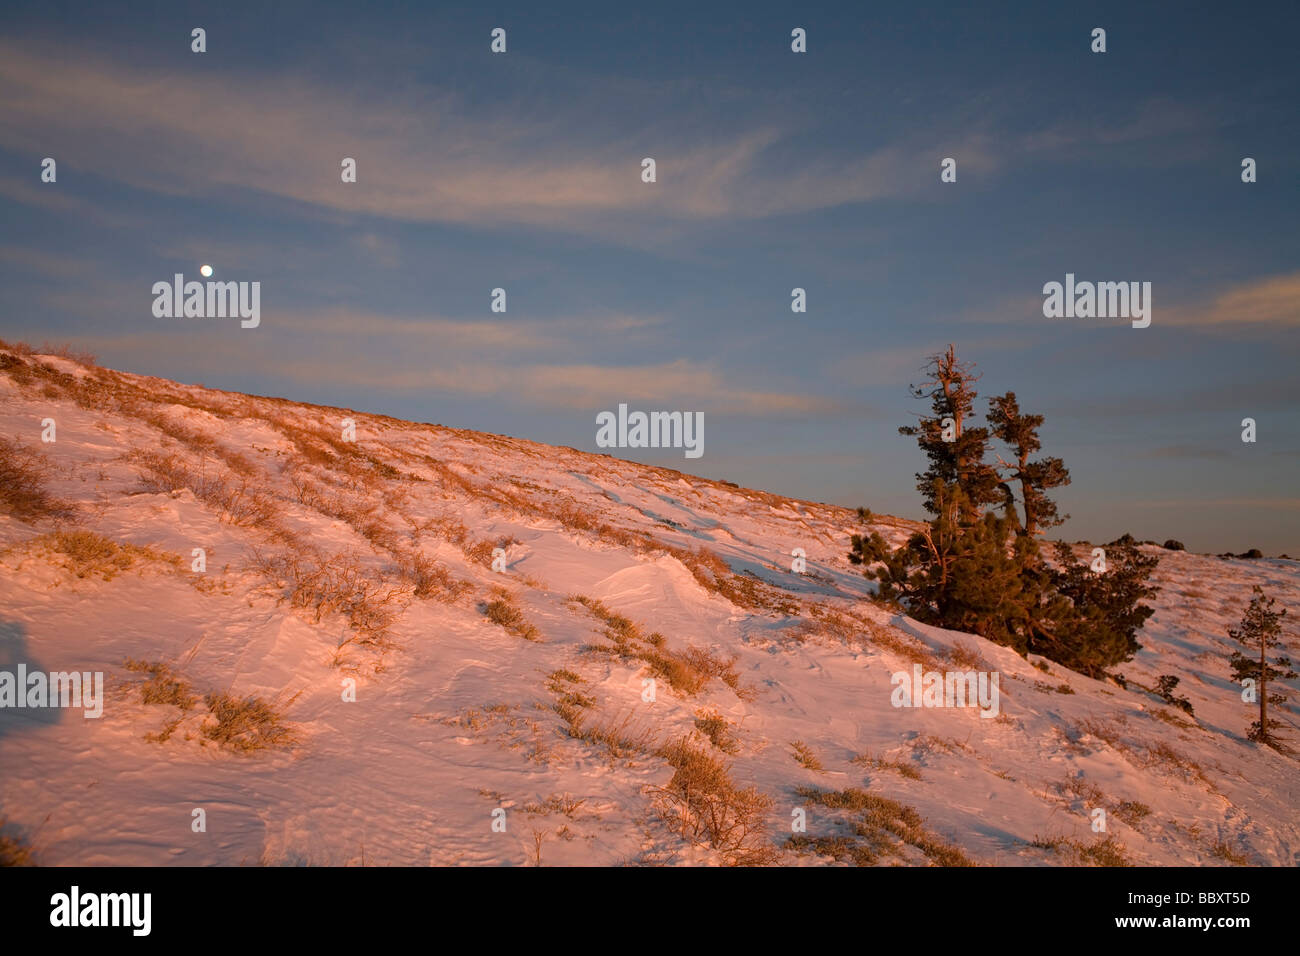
[655,739,776,866]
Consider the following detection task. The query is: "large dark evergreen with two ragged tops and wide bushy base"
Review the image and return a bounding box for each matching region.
[849,346,1158,676]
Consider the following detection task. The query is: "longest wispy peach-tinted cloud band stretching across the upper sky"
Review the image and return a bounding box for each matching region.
[0,40,997,230]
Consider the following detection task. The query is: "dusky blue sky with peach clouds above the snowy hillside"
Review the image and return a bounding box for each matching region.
[0,0,1300,555]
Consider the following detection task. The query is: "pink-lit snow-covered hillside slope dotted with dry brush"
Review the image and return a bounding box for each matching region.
[0,351,1300,865]
